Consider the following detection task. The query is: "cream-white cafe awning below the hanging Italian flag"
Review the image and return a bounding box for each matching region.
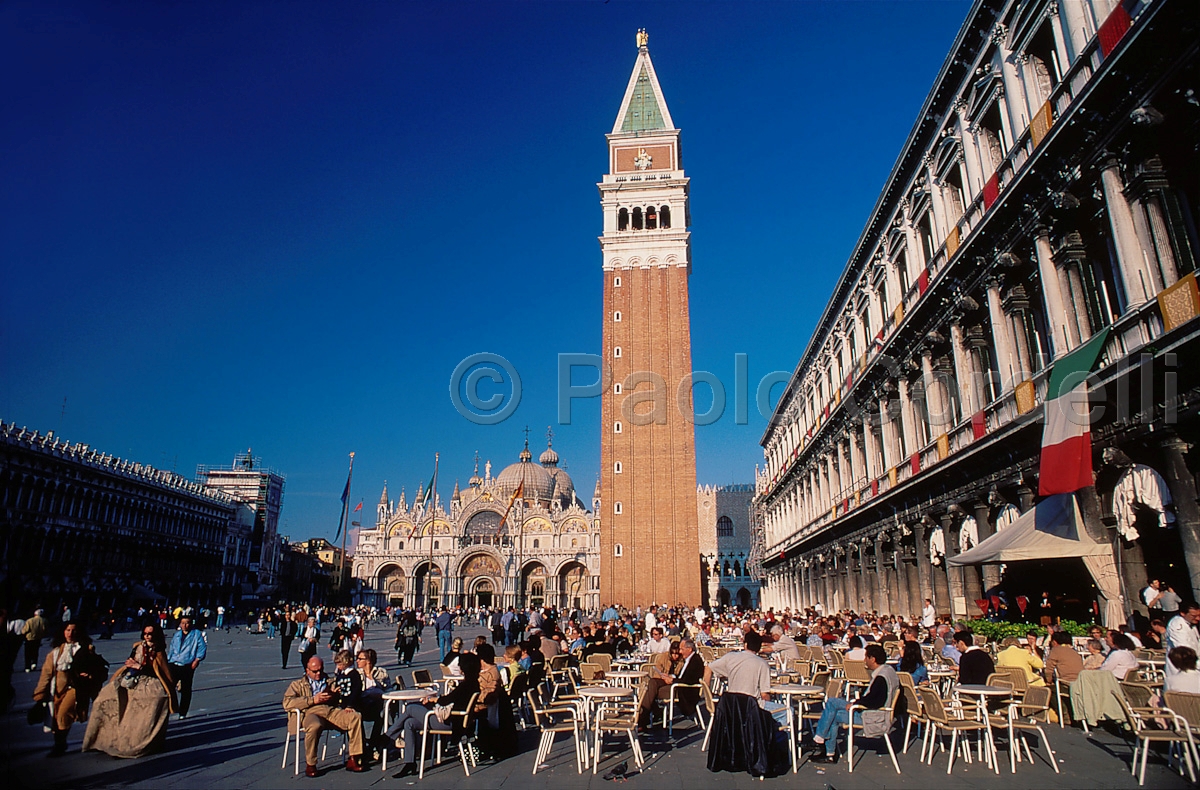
[947,496,1112,565]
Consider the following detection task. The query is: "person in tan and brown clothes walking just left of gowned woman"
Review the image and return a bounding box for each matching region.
[34,621,104,758]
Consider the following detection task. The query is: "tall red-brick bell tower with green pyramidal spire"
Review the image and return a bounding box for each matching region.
[599,30,700,606]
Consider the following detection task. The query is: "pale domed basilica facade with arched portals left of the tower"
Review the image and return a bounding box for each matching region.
[354,439,600,609]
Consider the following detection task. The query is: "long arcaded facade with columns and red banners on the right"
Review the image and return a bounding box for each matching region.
[755,0,1200,622]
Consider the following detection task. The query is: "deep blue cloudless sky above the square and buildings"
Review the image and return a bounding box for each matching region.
[0,0,968,539]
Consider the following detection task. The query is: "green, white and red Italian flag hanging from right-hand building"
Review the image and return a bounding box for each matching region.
[1038,329,1109,496]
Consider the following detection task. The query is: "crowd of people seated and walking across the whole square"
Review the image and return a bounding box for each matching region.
[0,587,1200,776]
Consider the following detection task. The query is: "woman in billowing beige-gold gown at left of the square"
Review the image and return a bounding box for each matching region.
[83,626,175,758]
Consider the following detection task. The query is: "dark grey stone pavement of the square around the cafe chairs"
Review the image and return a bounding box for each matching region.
[0,623,1187,790]
